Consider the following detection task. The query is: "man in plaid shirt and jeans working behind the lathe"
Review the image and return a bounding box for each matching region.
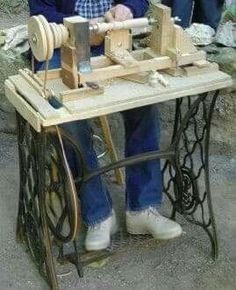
[29,0,182,250]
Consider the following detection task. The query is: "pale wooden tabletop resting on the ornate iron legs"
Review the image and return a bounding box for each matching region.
[5,71,232,132]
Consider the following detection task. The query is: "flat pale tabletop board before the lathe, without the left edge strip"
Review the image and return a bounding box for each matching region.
[40,71,232,126]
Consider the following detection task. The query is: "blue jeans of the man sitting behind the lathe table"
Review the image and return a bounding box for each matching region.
[38,48,162,225]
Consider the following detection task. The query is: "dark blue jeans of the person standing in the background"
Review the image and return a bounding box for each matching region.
[162,0,224,29]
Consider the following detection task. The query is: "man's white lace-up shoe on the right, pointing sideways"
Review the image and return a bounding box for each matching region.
[126,207,182,240]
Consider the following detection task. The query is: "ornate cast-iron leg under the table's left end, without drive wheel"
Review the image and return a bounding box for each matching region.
[17,114,58,289]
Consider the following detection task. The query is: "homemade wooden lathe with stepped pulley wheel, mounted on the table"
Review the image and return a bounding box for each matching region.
[24,5,217,97]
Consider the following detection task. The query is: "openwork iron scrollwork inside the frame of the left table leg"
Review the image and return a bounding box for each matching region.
[17,114,46,275]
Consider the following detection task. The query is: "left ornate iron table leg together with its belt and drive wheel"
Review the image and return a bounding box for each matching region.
[16,114,85,290]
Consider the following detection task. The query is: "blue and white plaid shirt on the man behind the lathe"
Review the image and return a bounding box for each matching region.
[75,0,114,19]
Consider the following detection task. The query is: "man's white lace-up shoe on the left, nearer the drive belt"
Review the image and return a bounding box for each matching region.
[85,210,118,251]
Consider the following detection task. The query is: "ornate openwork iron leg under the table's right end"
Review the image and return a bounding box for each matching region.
[163,91,219,259]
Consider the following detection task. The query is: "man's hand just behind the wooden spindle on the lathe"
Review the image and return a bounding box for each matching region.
[105,4,133,22]
